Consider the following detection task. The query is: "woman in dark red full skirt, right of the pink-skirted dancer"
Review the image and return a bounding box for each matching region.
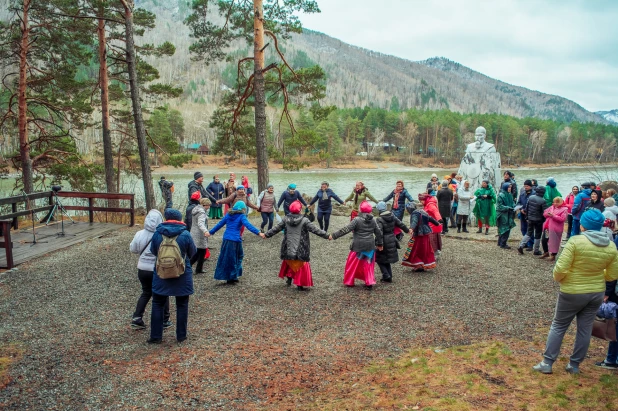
[401,203,440,271]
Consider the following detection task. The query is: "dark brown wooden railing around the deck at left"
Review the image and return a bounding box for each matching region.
[0,191,135,269]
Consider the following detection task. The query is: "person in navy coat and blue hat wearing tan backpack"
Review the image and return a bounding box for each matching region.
[148,208,197,344]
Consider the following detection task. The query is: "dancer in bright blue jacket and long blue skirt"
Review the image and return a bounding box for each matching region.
[206,201,265,284]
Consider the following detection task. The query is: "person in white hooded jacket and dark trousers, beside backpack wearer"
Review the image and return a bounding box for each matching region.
[129,210,172,330]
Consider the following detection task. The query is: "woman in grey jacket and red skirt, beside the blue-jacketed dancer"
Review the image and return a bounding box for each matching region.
[265,200,328,291]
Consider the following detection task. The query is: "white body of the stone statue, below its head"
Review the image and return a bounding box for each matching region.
[459,152,502,193]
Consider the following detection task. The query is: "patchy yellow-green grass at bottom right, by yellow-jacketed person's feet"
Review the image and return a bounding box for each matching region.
[292,341,618,411]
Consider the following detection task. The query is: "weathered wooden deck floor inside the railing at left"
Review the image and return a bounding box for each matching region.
[0,220,126,268]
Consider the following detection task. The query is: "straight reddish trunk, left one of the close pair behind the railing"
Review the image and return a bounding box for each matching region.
[97,9,116,198]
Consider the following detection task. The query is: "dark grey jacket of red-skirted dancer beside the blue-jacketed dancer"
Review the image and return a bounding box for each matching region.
[265,214,328,261]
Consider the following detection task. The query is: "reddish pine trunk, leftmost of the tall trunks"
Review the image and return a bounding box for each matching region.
[17,0,34,193]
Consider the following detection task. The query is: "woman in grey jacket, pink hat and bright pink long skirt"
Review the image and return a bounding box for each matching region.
[331,201,383,288]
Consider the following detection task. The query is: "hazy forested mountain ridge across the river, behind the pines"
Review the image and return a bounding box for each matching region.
[138,0,608,123]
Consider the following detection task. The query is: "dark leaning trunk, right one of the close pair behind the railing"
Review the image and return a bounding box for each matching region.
[121,0,155,210]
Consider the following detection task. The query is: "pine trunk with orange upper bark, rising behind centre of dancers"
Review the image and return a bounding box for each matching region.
[253,0,268,192]
